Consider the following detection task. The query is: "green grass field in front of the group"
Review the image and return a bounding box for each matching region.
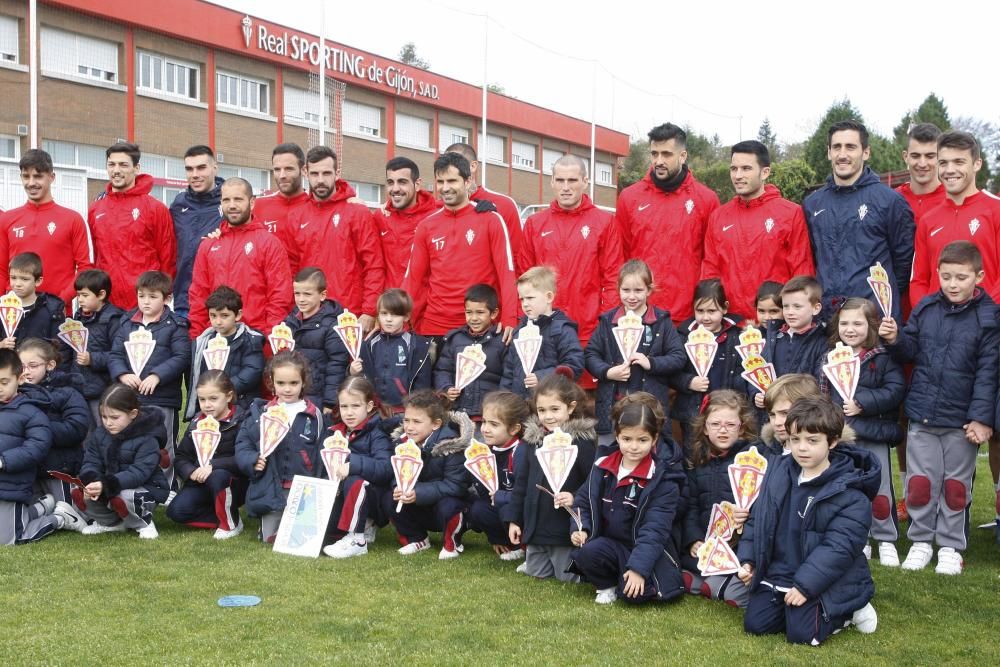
[0,457,1000,666]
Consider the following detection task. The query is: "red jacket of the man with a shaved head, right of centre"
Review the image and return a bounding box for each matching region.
[517,195,622,347]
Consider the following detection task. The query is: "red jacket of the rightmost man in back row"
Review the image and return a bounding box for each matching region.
[910,191,1000,307]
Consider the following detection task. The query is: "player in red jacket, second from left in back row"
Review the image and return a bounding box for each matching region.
[87,143,177,310]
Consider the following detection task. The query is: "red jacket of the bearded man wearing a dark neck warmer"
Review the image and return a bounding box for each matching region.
[615,173,719,324]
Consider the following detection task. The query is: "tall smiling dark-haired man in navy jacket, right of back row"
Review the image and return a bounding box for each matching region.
[802,120,914,320]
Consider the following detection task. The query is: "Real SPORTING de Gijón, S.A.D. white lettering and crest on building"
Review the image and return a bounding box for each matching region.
[240,16,439,100]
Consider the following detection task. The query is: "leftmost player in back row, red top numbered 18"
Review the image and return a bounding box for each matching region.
[0,149,94,303]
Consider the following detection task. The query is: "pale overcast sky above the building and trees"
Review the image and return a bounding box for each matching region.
[216,0,1000,144]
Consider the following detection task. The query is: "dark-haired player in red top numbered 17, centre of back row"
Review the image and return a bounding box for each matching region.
[403,153,518,336]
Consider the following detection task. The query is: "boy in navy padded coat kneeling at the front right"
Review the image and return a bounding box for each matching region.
[737,397,881,646]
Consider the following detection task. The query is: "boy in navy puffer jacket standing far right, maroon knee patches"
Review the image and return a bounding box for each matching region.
[879,241,1000,575]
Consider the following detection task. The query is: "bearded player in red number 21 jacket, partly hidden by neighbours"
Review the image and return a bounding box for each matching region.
[253,144,309,275]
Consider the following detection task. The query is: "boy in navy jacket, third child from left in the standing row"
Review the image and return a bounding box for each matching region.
[108,271,191,489]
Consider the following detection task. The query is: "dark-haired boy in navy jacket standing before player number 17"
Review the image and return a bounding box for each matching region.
[434,284,508,421]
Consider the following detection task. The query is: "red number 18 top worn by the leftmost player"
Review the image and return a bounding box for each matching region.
[0,201,94,304]
